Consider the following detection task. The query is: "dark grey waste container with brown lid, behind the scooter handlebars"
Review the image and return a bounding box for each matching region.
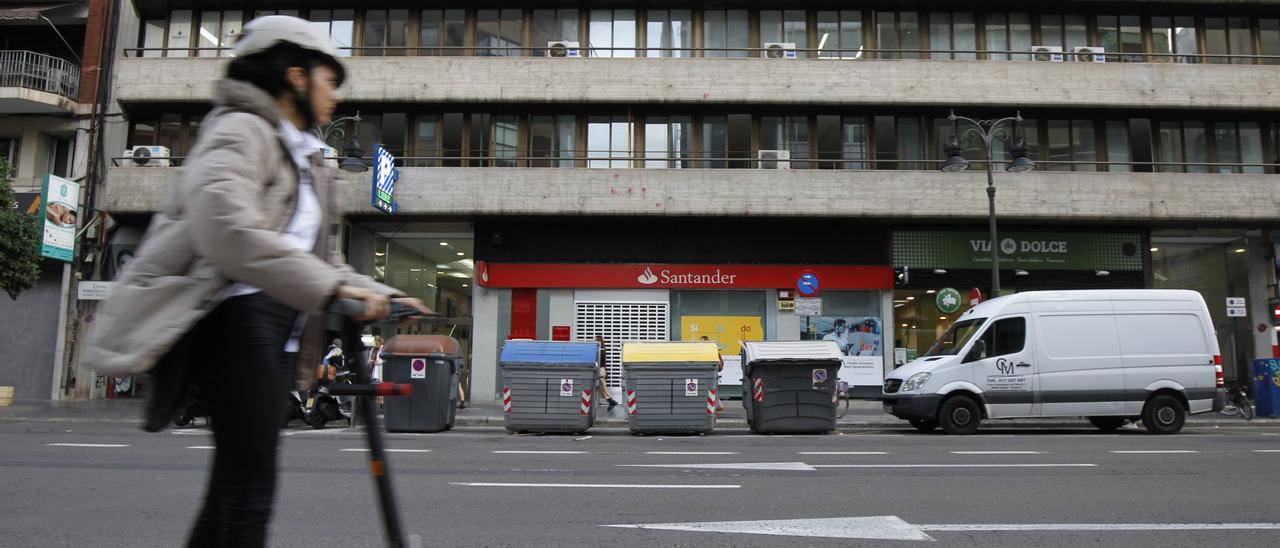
[381,335,462,433]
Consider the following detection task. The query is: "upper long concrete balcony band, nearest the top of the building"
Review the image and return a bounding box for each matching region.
[115,56,1280,110]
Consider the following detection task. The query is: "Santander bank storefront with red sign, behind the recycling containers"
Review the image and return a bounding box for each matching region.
[475,220,893,396]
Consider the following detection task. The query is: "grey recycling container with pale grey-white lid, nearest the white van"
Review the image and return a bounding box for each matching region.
[742,341,844,434]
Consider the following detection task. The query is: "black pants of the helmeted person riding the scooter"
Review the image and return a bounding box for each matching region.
[187,293,298,547]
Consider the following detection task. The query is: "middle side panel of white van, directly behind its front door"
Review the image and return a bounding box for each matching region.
[1034,309,1125,416]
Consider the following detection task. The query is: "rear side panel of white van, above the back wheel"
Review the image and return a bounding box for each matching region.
[1116,309,1216,414]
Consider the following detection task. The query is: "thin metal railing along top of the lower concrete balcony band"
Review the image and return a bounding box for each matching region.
[111,151,1280,175]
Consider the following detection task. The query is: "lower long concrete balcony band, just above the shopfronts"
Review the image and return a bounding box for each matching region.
[100,163,1280,224]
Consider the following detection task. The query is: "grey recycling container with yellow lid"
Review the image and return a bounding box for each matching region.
[622,342,721,434]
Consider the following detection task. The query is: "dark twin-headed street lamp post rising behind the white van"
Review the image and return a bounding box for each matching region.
[942,110,1036,297]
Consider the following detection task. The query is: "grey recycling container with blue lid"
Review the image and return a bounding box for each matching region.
[498,341,600,433]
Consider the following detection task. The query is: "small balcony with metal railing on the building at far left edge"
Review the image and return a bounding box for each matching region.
[0,50,79,114]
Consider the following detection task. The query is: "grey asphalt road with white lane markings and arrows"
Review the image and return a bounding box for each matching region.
[0,421,1280,548]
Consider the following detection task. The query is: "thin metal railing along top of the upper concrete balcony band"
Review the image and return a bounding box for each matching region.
[124,45,1280,65]
